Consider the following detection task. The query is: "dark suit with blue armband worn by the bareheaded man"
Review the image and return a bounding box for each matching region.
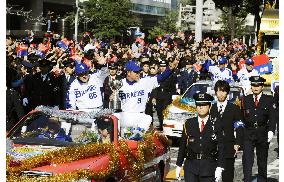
[210,102,243,182]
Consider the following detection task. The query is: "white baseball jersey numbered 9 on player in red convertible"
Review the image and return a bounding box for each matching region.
[119,77,158,112]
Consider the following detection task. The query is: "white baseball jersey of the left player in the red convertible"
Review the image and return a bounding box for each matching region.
[67,70,107,109]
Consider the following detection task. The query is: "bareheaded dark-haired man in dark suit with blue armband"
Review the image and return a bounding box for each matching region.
[210,80,243,182]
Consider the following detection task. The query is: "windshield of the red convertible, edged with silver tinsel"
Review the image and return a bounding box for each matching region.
[9,112,113,145]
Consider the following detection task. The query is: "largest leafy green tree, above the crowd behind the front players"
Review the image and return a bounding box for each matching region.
[65,0,141,38]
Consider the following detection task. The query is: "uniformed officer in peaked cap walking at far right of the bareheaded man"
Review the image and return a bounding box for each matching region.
[242,76,275,182]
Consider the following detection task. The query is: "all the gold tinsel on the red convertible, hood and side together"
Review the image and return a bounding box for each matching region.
[6,132,168,182]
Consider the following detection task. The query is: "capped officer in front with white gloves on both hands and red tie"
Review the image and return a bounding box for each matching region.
[176,93,223,182]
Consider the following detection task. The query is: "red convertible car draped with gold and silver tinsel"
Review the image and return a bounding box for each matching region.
[6,106,170,182]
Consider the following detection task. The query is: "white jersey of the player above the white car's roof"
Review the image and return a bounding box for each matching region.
[208,66,233,83]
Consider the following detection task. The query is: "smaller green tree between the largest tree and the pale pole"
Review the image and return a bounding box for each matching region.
[149,11,178,38]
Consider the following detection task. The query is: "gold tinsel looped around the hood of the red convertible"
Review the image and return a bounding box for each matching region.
[6,143,118,182]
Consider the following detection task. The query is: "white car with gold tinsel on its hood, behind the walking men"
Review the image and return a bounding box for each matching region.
[163,80,244,138]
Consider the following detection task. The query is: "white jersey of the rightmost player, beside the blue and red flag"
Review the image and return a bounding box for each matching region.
[237,67,259,93]
